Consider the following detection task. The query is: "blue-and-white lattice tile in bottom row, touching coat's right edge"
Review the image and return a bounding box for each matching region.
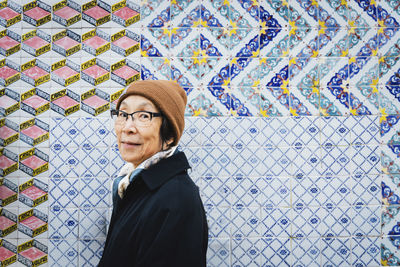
[207,238,231,267]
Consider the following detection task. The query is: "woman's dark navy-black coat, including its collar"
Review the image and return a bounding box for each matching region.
[99,152,208,267]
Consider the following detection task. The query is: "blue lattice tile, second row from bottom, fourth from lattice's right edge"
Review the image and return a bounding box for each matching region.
[260,207,292,238]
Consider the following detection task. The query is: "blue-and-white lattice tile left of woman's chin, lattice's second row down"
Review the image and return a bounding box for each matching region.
[79,146,110,177]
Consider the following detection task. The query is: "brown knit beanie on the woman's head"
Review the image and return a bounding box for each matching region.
[116,80,187,146]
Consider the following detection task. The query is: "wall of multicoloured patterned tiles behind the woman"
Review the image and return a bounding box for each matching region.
[0,0,400,267]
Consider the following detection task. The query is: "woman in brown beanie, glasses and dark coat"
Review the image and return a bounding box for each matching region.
[99,80,208,267]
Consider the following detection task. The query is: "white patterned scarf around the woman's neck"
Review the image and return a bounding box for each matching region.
[118,146,177,198]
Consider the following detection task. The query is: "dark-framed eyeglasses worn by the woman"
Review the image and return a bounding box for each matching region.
[111,109,162,127]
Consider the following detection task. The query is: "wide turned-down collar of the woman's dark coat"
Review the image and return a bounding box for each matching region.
[141,152,190,191]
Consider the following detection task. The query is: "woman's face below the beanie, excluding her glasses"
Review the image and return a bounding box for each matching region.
[114,95,162,167]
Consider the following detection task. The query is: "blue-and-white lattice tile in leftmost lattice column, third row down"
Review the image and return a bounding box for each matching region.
[49,178,80,209]
